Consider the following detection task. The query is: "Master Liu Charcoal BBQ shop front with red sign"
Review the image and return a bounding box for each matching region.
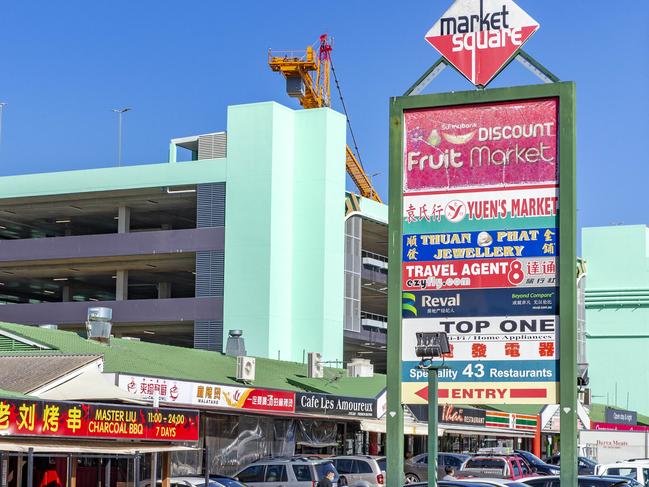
[0,398,199,487]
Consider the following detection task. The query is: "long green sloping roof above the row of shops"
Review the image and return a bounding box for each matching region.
[0,322,386,397]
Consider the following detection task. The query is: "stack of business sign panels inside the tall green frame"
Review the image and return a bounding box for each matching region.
[401,97,559,404]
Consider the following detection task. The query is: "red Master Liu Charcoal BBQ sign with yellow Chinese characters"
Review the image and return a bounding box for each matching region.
[0,398,199,442]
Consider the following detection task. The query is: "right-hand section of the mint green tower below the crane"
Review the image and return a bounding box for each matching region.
[292,109,346,360]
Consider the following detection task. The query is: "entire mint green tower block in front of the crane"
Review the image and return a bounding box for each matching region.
[224,103,345,361]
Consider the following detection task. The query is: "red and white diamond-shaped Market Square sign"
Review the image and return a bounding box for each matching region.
[426,0,539,86]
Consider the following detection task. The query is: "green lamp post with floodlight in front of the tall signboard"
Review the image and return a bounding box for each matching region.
[415,332,451,487]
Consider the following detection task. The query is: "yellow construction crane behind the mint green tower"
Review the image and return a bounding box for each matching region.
[268,34,381,203]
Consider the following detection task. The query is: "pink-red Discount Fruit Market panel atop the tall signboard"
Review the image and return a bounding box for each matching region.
[403,99,559,192]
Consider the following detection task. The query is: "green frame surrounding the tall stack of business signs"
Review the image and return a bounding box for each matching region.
[387,82,577,487]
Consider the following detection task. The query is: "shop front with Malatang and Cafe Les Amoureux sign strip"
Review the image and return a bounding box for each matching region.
[117,374,385,475]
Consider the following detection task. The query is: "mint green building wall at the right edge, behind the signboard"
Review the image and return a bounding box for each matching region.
[582,225,649,414]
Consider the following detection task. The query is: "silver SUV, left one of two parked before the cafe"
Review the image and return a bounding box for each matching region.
[235,457,339,487]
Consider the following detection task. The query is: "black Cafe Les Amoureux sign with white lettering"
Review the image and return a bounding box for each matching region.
[295,392,377,418]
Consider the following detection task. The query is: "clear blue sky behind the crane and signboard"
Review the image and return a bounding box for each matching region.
[0,0,649,234]
